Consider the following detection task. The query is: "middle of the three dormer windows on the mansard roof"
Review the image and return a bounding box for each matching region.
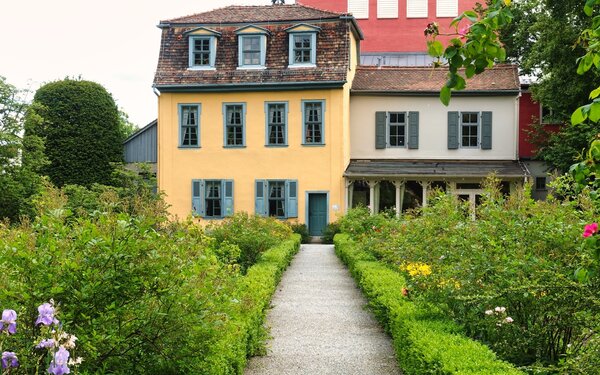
[235,25,269,69]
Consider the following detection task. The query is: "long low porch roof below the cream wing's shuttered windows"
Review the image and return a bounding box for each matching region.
[344,159,529,179]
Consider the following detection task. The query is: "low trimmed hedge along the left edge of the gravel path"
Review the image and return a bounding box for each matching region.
[203,234,300,375]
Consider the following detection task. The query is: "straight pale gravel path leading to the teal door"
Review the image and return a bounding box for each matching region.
[245,245,401,375]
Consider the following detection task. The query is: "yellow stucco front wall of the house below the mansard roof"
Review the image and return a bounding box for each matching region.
[158,89,349,222]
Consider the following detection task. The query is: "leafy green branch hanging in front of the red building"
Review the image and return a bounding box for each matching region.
[425,0,513,106]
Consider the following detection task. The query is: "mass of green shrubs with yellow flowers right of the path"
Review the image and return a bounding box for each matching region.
[340,184,600,366]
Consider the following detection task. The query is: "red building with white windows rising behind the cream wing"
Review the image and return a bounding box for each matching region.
[296,0,482,54]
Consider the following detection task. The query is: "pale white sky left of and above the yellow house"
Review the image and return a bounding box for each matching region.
[0,0,294,127]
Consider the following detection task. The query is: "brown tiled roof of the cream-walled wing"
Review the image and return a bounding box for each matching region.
[352,64,520,93]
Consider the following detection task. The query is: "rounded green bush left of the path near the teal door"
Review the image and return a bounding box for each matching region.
[207,212,292,272]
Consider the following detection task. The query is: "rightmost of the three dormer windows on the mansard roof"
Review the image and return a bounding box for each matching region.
[286,24,321,68]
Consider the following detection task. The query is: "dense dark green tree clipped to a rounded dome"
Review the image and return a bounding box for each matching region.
[27,78,124,186]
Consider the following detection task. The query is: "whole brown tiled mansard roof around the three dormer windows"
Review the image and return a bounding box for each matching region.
[154,5,355,89]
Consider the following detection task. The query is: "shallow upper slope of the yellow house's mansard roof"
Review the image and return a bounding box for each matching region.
[160,4,345,24]
